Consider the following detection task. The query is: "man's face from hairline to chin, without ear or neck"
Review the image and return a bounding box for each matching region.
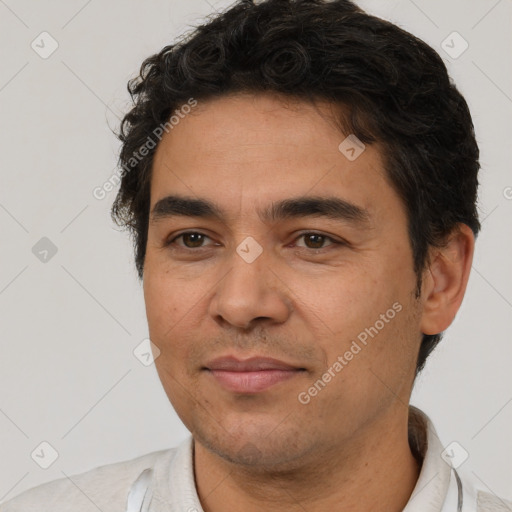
[144,91,421,467]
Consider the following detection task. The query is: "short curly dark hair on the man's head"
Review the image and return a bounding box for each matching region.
[111,0,480,375]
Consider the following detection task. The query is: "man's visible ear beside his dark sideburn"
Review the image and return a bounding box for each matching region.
[421,224,475,334]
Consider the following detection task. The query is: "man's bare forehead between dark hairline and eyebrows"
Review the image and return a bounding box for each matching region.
[151,94,397,220]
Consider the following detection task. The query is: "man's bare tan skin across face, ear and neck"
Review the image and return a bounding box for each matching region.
[144,94,474,512]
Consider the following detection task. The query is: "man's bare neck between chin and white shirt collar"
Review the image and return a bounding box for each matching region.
[194,408,420,512]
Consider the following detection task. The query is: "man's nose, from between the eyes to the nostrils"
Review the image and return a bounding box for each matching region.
[209,245,292,330]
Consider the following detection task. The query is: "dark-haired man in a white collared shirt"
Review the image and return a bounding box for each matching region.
[1,0,512,512]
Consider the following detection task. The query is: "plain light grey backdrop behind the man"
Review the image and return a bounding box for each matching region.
[0,0,512,501]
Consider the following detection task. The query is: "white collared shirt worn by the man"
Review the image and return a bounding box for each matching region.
[0,406,512,512]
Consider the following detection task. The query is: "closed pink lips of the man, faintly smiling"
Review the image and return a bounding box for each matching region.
[203,356,306,394]
